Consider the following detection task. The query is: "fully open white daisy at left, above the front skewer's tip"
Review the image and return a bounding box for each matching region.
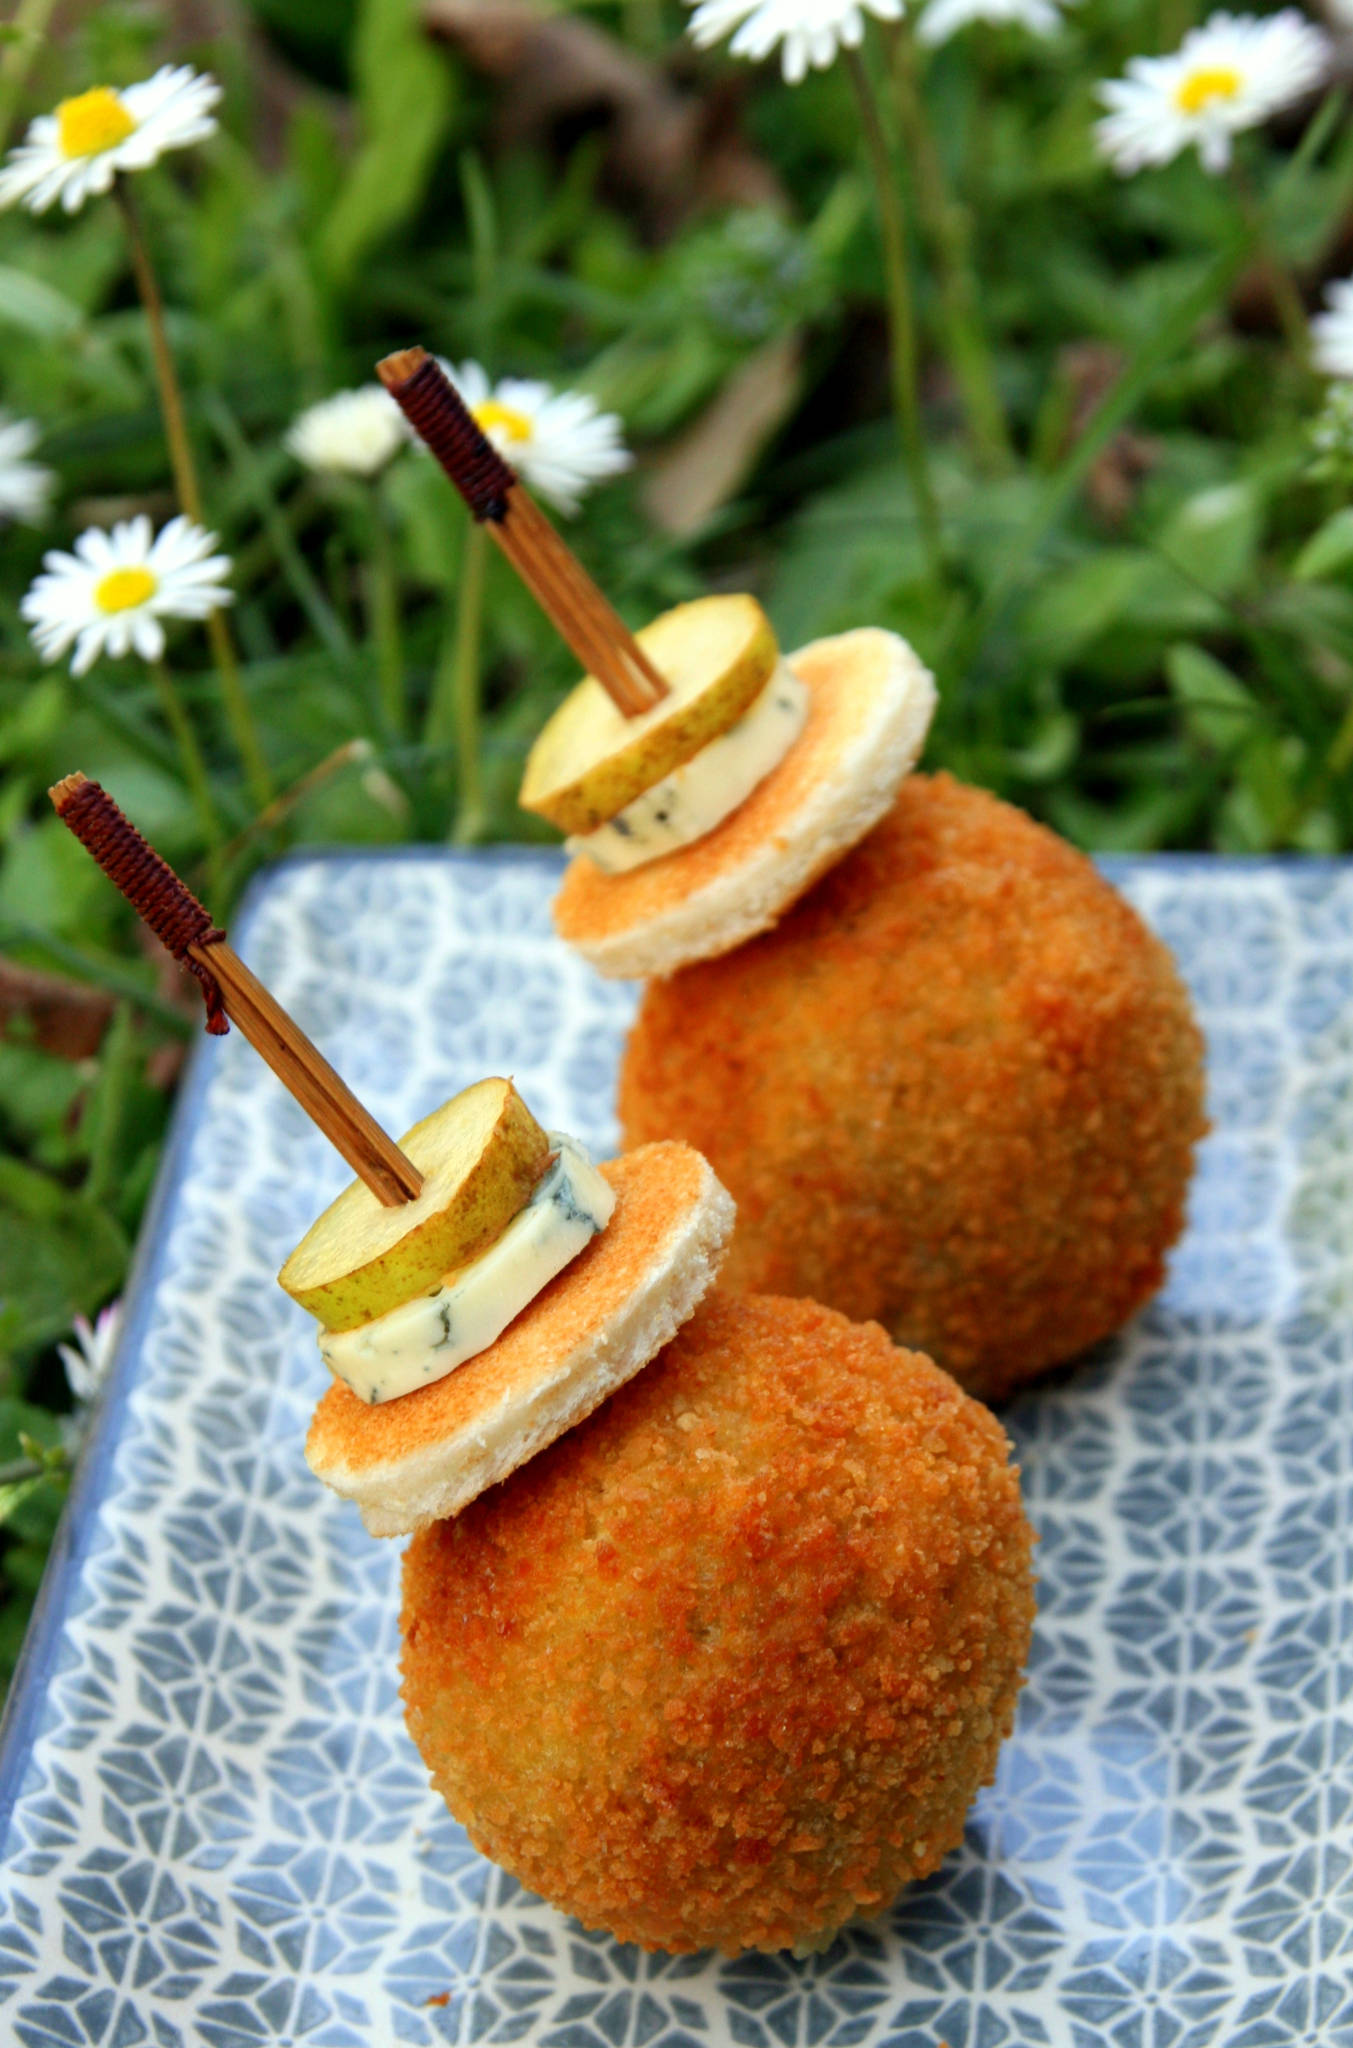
[18,512,233,676]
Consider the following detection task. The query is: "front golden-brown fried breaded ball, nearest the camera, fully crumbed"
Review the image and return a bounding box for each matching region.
[401,1290,1034,1954]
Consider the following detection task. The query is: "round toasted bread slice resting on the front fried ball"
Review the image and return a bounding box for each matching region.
[305,1143,733,1536]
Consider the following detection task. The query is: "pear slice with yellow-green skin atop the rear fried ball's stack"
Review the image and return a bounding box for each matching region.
[520,594,780,831]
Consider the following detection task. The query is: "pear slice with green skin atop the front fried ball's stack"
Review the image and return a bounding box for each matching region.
[278,1079,551,1331]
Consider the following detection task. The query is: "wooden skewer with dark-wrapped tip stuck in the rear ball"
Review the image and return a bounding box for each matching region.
[377,348,667,719]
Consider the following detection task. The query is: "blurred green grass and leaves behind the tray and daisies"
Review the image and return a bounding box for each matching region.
[0,0,1353,1669]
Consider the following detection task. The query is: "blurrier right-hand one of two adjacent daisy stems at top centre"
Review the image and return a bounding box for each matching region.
[892,16,1013,469]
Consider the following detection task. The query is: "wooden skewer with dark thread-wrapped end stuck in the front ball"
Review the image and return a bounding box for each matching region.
[47,772,424,1208]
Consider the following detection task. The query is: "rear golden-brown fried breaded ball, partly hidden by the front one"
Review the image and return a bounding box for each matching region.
[620,774,1206,1399]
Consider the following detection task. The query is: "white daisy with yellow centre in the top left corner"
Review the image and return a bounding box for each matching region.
[0,63,221,213]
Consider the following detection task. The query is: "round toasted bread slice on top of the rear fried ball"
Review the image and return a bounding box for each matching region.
[555,627,935,979]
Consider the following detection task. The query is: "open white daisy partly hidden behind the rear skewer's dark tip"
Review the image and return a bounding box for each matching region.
[442,362,632,512]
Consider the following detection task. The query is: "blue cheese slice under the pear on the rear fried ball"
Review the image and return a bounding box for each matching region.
[567,657,809,874]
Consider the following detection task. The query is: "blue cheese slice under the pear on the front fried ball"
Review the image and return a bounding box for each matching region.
[319,1130,616,1403]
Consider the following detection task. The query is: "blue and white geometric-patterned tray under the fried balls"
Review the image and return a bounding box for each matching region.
[0,852,1353,2048]
